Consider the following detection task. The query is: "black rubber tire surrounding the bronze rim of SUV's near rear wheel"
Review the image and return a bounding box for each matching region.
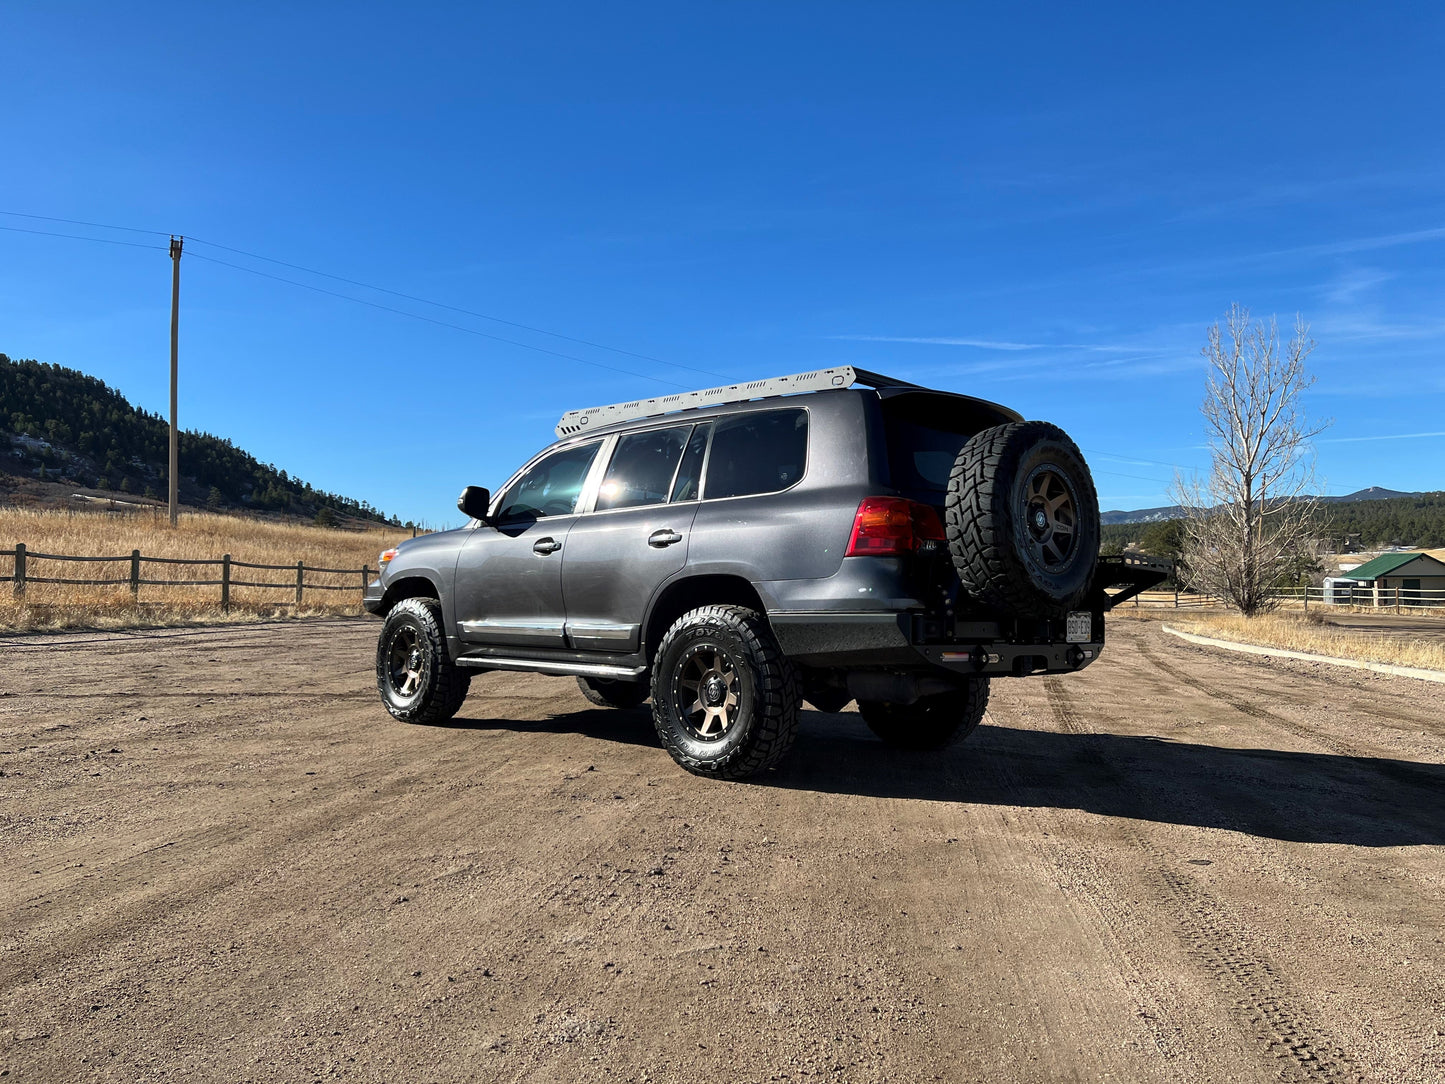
[652,606,802,779]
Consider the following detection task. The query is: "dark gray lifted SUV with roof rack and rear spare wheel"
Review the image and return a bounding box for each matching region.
[366,367,1163,779]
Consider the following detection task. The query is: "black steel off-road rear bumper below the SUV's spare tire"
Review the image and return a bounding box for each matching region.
[769,611,1104,676]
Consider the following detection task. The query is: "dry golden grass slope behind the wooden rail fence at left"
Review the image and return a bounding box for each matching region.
[0,507,410,630]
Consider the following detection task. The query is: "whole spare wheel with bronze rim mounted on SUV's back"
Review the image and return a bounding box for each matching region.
[946,422,1098,617]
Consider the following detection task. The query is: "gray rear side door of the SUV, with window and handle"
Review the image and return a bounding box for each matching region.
[562,423,711,655]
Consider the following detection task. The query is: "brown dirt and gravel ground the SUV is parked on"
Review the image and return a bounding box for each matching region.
[0,620,1445,1084]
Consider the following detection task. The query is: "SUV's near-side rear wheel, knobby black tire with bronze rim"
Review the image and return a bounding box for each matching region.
[652,606,802,779]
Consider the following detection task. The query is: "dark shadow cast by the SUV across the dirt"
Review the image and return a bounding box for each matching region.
[442,708,1445,847]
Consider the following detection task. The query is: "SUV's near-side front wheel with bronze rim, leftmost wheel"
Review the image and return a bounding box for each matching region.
[376,598,471,724]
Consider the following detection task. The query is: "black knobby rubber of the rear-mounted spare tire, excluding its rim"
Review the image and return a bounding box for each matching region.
[944,422,1100,617]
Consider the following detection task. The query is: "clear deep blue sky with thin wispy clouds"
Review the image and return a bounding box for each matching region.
[0,3,1445,525]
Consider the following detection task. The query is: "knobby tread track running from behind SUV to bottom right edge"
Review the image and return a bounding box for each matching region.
[1043,678,1364,1081]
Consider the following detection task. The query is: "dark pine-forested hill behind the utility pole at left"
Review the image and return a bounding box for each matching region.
[0,354,394,522]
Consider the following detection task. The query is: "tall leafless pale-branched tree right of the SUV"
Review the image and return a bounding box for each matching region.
[1175,305,1329,617]
